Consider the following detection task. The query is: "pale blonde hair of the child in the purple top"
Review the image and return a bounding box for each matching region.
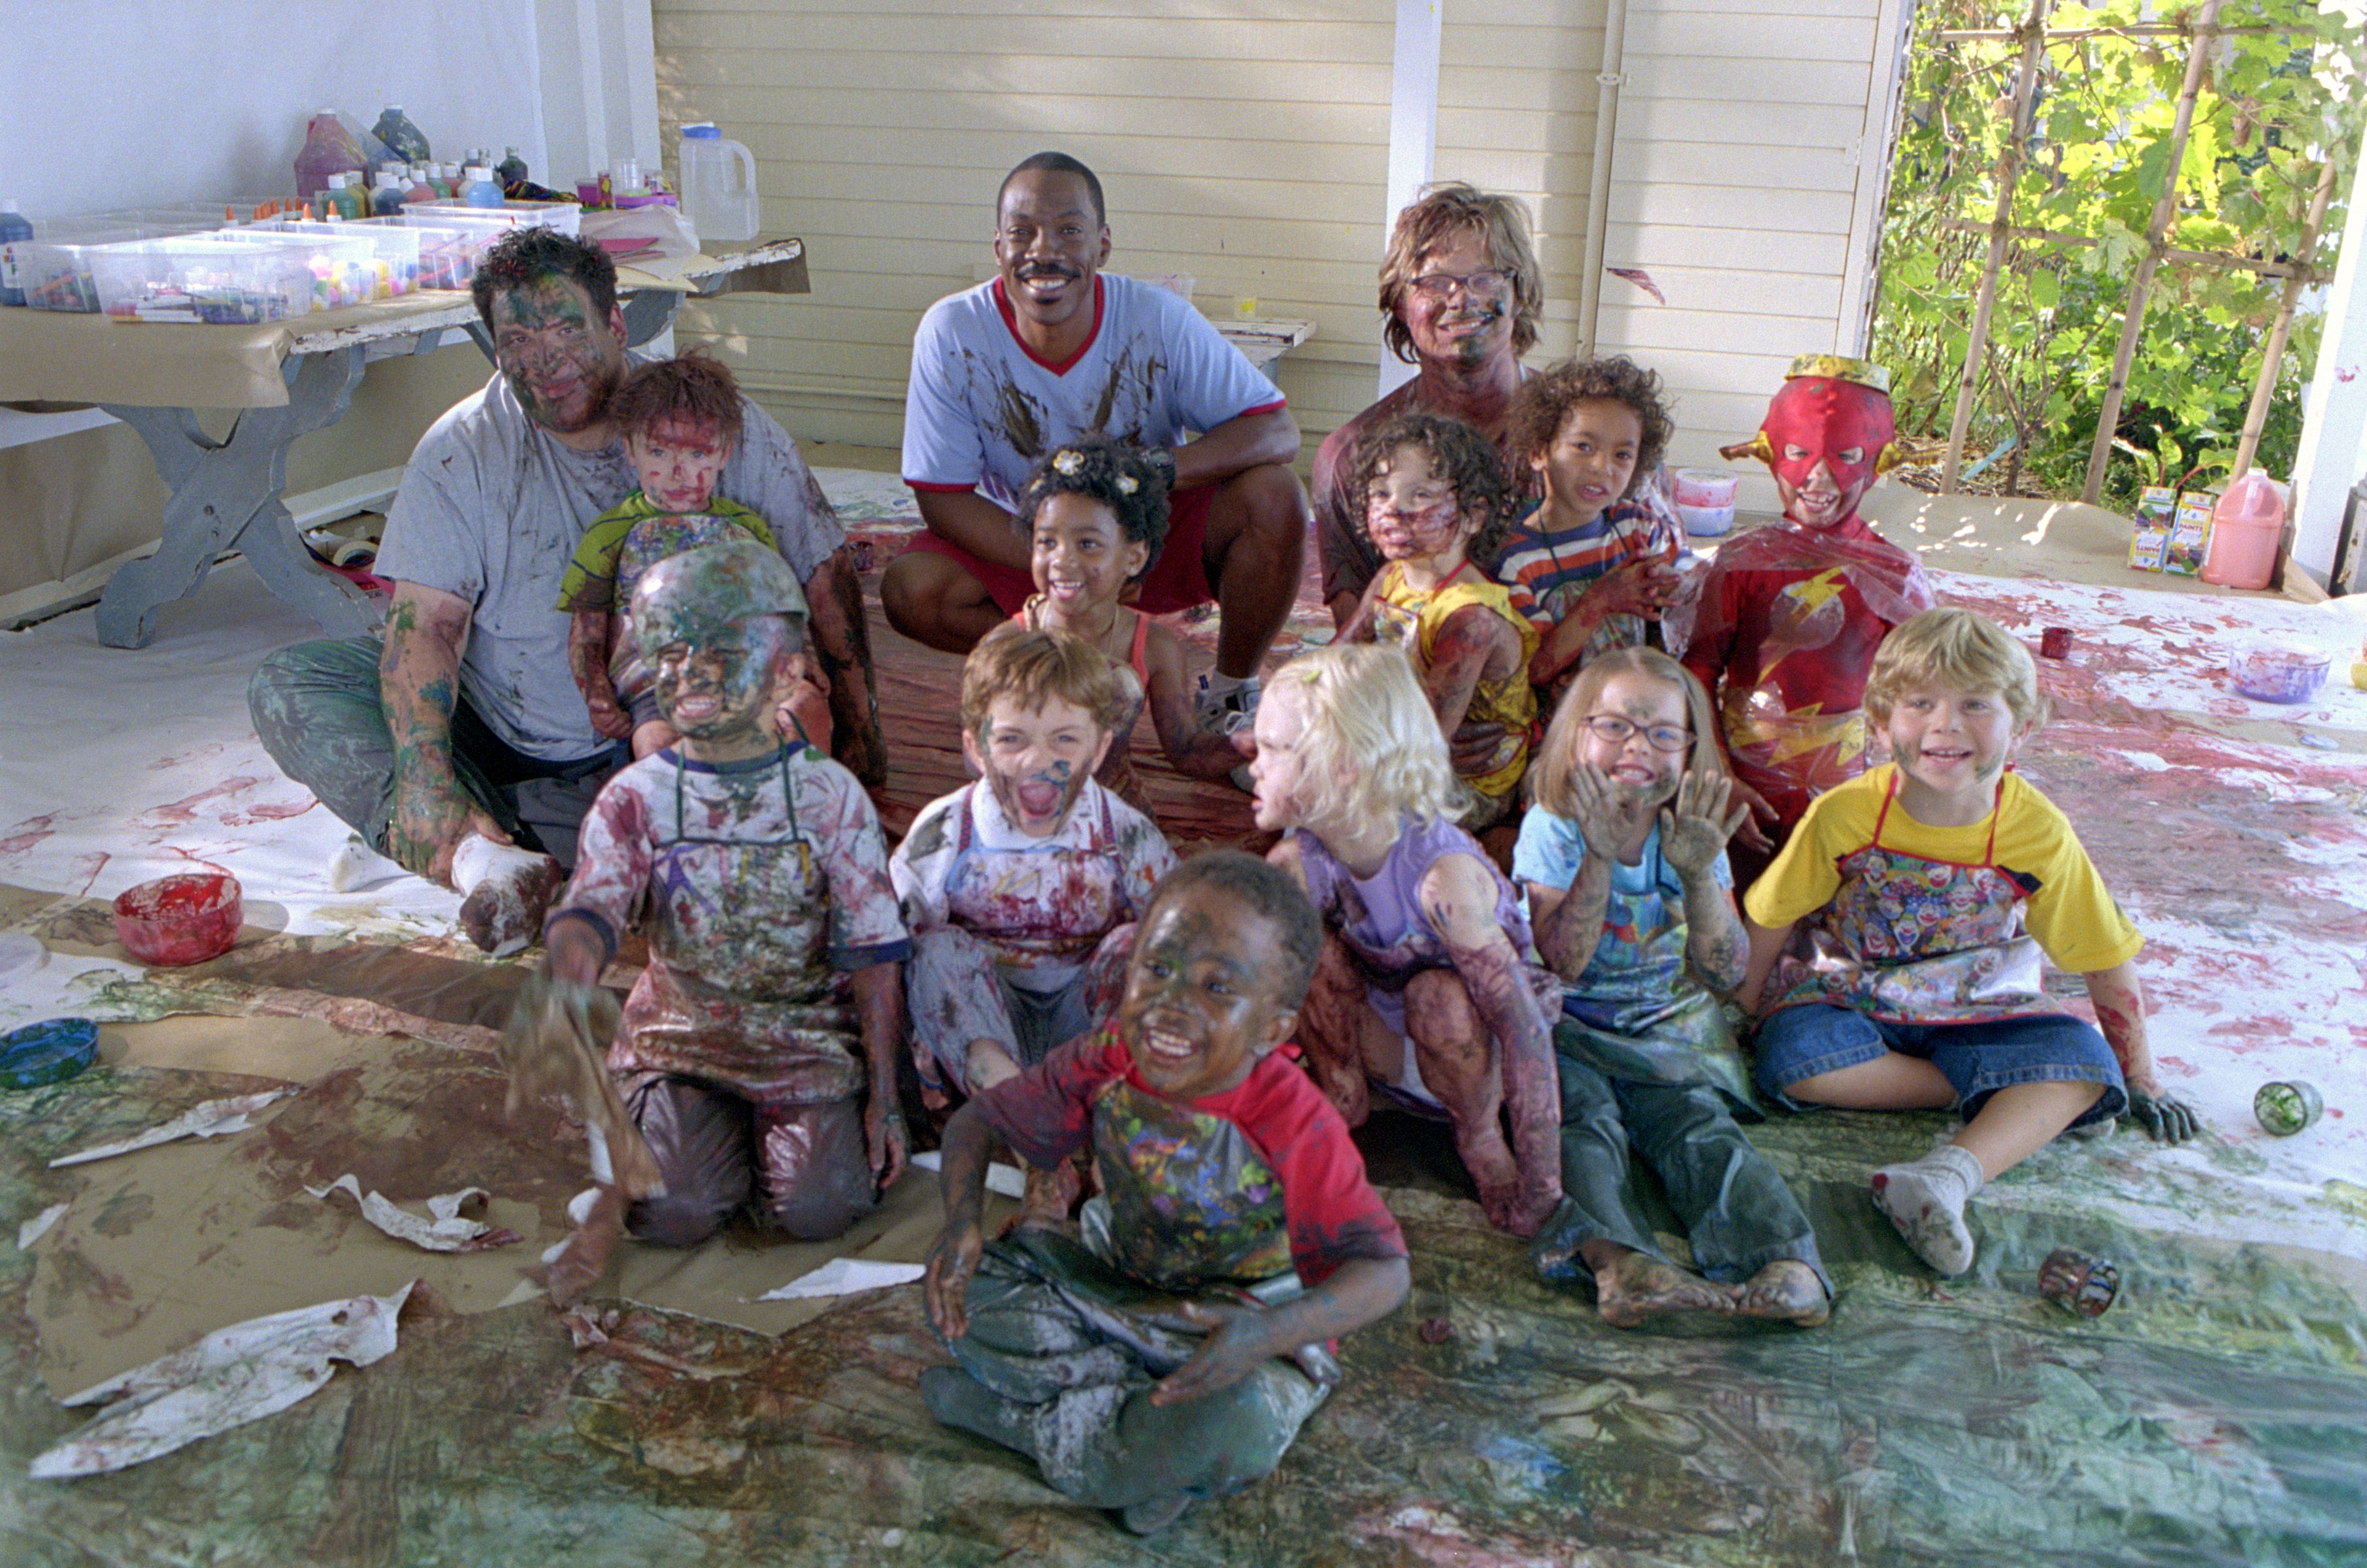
[1274,644,1470,823]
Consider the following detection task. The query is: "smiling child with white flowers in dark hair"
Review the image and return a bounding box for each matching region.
[1013,435,1240,811]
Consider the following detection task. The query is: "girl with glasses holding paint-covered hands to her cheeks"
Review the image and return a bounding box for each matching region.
[1512,648,1832,1329]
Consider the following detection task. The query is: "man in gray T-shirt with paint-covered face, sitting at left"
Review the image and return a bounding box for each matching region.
[248,229,886,951]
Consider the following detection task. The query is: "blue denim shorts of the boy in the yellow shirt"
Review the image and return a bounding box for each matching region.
[1757,1003,2128,1128]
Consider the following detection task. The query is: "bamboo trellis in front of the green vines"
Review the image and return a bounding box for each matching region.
[1936,0,2336,504]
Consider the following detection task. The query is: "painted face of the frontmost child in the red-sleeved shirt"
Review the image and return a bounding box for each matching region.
[1117,882,1297,1100]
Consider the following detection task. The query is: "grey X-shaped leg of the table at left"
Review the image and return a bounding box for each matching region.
[99,346,381,648]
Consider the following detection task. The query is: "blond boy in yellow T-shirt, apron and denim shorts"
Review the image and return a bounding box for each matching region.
[1744,610,2194,1275]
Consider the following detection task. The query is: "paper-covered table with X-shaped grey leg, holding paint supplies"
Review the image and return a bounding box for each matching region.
[0,239,810,648]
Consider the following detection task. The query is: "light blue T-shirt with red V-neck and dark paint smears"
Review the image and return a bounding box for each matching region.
[904,272,1287,506]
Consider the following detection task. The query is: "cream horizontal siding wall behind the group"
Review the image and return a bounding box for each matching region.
[655,0,1898,487]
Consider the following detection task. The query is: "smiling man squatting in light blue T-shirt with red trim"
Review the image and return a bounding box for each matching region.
[880,152,1306,731]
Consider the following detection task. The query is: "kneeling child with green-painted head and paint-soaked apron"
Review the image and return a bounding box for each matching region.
[544,539,911,1296]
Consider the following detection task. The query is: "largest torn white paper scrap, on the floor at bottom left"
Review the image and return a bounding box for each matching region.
[33,1279,416,1480]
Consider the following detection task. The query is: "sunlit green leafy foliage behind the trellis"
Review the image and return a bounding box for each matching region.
[1875,0,2362,501]
